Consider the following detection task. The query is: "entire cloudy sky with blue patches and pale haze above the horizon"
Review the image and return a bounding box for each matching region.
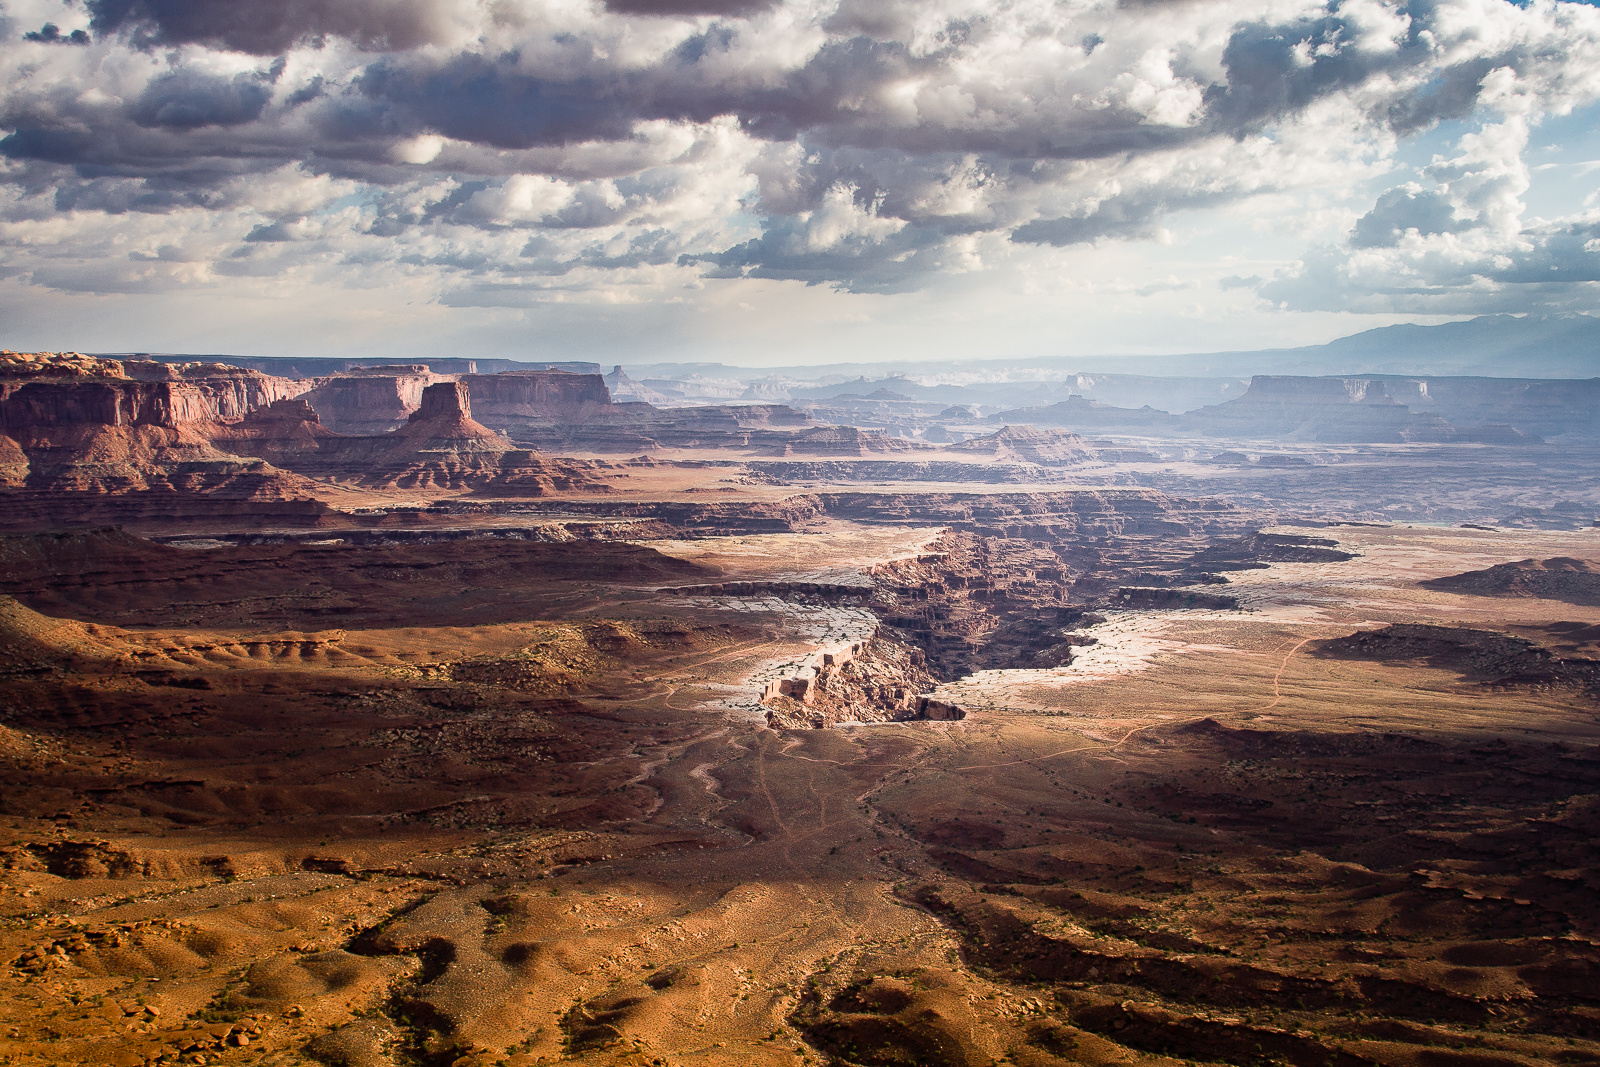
[0,0,1600,366]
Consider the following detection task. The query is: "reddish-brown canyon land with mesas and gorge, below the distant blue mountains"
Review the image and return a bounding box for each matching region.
[0,352,1600,1067]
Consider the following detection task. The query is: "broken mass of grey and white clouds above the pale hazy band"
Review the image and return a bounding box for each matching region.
[0,0,1600,309]
